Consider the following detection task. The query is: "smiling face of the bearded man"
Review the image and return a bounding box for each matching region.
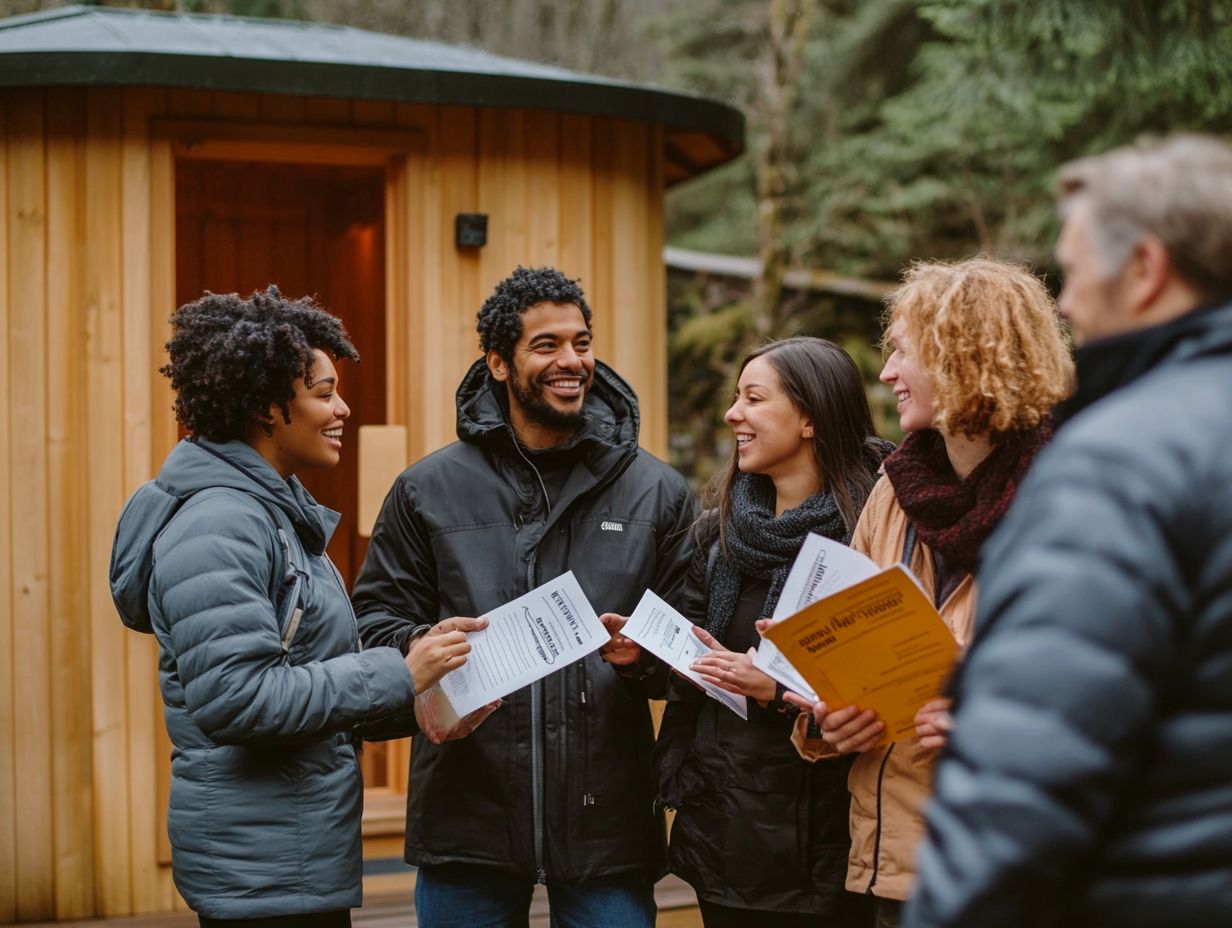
[488,303,595,449]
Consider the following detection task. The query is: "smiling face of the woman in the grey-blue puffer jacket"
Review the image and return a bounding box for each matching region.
[249,349,351,479]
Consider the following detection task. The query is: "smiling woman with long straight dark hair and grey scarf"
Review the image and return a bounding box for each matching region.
[655,338,893,928]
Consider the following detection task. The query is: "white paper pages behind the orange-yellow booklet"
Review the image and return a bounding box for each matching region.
[753,532,881,702]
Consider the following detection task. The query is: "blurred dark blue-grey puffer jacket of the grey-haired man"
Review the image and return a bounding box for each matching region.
[908,306,1232,928]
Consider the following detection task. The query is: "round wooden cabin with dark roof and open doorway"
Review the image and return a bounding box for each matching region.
[0,7,743,922]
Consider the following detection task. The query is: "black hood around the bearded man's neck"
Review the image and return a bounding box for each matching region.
[456,357,641,451]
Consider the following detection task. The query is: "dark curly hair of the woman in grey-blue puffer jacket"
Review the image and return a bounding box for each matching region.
[159,285,360,441]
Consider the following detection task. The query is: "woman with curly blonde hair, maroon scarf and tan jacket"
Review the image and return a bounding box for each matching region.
[795,258,1073,928]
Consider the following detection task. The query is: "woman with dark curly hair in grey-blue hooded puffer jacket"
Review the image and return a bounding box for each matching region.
[112,287,480,927]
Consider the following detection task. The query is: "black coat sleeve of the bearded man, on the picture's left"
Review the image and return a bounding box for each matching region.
[351,474,440,653]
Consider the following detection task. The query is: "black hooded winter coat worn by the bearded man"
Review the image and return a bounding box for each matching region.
[354,360,695,881]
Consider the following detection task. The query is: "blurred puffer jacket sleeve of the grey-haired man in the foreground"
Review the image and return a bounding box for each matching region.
[906,433,1201,928]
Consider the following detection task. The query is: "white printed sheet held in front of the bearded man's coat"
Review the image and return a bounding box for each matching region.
[437,571,610,717]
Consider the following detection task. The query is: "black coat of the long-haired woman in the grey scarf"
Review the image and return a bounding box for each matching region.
[655,519,853,924]
